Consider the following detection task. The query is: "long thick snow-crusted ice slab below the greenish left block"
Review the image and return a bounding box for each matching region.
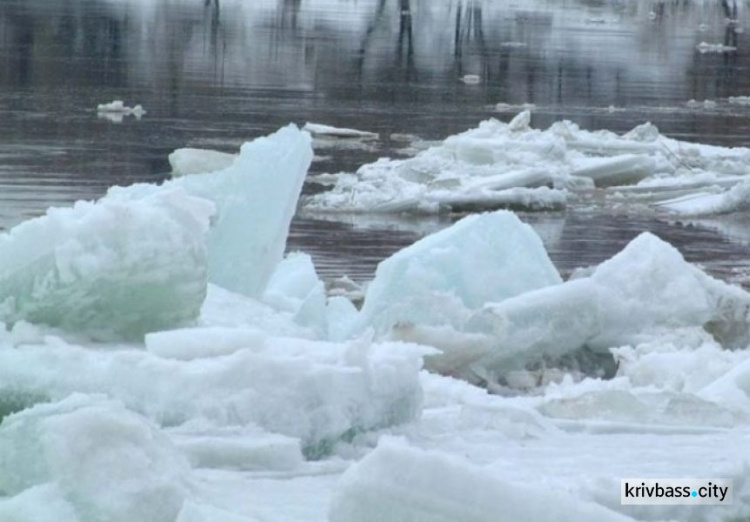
[0,328,427,452]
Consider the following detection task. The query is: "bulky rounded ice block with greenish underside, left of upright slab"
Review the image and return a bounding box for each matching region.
[0,186,215,338]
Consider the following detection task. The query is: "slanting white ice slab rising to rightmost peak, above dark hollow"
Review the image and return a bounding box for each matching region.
[464,233,750,380]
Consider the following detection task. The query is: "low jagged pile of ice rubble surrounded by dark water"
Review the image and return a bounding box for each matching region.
[304,111,750,213]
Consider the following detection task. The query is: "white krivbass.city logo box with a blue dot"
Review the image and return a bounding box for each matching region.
[620,478,734,506]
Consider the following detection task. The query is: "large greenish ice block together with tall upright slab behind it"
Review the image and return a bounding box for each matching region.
[0,127,312,338]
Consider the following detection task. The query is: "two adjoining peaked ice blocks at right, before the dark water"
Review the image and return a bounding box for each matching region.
[374,225,750,383]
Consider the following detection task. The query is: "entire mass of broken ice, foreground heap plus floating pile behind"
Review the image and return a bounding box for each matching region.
[0,118,750,522]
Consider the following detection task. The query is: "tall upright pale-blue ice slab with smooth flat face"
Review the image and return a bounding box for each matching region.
[179,125,313,298]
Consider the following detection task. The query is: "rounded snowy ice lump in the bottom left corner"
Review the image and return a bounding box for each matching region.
[0,395,190,522]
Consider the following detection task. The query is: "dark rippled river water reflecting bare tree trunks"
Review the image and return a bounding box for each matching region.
[0,0,750,280]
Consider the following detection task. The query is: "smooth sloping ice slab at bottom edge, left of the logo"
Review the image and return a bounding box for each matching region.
[329,439,631,522]
